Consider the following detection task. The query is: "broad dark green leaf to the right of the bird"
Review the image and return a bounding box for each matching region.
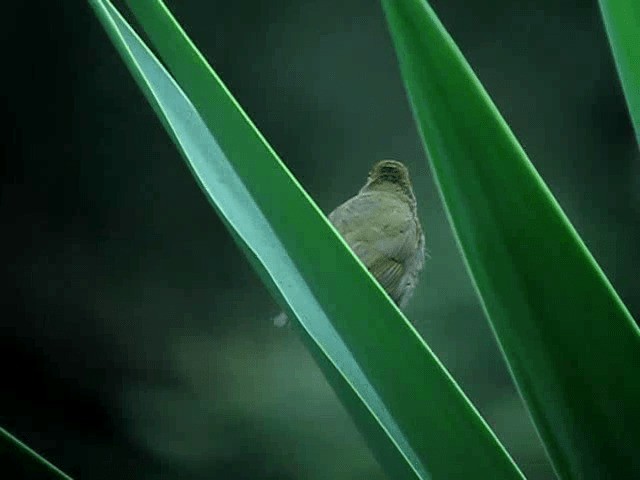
[383,0,640,480]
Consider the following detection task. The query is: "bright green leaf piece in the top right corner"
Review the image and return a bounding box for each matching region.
[600,0,640,145]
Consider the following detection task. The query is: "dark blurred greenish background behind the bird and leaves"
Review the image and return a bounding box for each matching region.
[0,0,640,480]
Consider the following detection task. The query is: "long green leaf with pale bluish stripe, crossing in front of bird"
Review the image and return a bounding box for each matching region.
[91,0,522,479]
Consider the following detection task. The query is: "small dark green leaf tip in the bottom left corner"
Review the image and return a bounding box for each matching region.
[0,427,71,480]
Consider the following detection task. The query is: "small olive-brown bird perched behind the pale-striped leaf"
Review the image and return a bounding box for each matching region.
[273,160,425,327]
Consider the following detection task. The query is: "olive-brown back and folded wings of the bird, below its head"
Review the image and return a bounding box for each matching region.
[329,194,419,301]
